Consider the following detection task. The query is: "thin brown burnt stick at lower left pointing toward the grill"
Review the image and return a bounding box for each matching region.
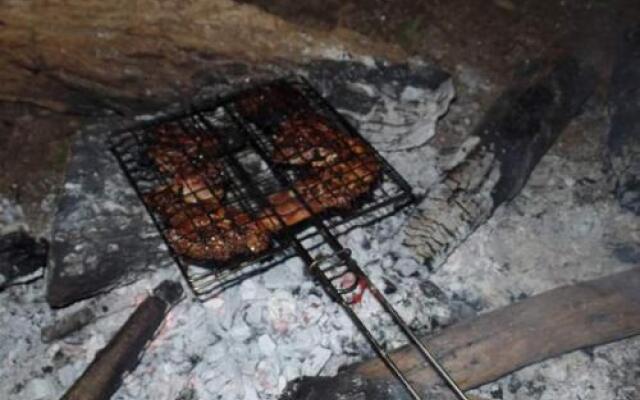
[61,281,182,400]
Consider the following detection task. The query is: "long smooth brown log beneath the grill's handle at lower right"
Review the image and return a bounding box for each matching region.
[283,268,640,400]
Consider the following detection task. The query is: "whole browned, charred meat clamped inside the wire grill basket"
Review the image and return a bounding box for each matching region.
[145,97,380,262]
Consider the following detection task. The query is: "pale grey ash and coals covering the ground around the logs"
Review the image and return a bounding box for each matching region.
[0,57,640,400]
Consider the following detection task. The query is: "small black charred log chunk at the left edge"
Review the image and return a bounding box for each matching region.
[0,231,49,291]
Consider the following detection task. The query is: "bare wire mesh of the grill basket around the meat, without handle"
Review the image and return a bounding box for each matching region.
[108,75,415,301]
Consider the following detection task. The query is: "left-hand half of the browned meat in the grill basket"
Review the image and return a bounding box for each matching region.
[145,126,276,261]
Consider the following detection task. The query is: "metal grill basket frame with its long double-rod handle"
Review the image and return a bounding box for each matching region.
[110,77,468,400]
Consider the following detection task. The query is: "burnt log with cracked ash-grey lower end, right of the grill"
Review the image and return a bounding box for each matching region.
[405,58,596,268]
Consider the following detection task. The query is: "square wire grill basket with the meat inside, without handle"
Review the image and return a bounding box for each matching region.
[109,77,413,298]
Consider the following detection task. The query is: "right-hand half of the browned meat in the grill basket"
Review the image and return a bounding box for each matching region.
[269,114,380,225]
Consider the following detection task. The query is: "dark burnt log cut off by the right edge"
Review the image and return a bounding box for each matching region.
[607,25,640,215]
